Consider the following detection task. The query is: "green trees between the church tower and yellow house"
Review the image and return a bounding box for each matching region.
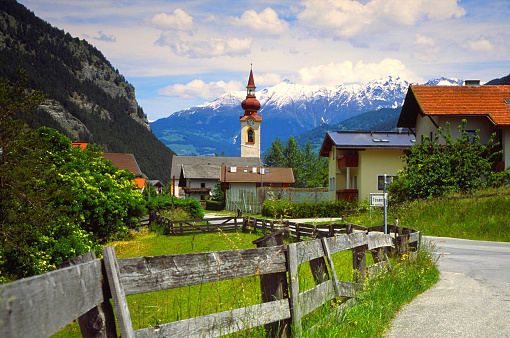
[264,136,328,188]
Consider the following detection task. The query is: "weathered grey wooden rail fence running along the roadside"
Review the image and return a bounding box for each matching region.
[0,218,420,337]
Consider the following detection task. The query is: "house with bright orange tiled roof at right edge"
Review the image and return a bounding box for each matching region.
[397,81,510,170]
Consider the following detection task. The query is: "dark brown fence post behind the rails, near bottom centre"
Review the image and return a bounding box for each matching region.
[252,229,290,337]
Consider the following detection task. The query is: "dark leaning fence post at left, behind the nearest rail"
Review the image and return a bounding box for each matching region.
[58,251,117,338]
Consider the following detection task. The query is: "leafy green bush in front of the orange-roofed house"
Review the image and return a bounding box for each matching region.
[389,120,503,203]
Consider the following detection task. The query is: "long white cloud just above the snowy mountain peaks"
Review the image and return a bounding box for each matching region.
[299,58,421,85]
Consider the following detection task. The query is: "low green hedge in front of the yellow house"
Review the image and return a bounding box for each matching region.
[262,200,357,218]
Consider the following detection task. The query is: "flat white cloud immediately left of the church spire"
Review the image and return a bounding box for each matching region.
[158,79,243,100]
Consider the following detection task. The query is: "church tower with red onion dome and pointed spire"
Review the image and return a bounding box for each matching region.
[239,69,262,157]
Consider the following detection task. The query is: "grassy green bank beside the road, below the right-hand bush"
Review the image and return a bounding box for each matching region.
[345,188,510,242]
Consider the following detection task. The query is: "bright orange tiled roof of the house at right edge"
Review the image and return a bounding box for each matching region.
[397,85,510,127]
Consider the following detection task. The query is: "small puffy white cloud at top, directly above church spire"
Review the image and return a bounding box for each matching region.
[234,7,289,35]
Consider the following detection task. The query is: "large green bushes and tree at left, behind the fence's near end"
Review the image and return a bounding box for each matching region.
[0,71,145,278]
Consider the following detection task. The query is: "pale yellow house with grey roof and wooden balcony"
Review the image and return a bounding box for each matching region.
[319,131,415,201]
